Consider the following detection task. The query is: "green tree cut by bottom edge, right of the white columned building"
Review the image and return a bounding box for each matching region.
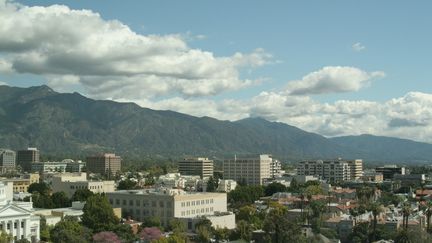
[50,216,90,243]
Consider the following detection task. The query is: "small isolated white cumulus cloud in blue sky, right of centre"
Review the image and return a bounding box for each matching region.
[287,66,385,95]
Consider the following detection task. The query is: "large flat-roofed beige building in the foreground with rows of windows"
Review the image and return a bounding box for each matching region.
[106,188,227,226]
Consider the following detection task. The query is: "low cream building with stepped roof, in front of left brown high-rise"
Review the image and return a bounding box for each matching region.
[52,173,115,197]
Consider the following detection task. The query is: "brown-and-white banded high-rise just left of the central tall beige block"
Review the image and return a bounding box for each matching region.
[178,158,213,178]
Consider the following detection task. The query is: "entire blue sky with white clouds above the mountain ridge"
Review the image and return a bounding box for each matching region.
[0,0,432,143]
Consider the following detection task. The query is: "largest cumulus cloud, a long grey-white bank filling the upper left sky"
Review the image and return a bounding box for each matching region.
[0,2,271,97]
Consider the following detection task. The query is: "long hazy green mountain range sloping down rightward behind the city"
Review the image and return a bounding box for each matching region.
[0,86,432,162]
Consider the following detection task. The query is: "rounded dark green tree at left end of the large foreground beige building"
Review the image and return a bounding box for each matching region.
[81,194,119,232]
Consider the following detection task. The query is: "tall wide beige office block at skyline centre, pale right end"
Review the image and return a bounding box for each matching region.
[223,154,272,185]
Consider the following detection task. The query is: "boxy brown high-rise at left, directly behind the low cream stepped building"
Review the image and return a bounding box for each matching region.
[86,154,121,175]
